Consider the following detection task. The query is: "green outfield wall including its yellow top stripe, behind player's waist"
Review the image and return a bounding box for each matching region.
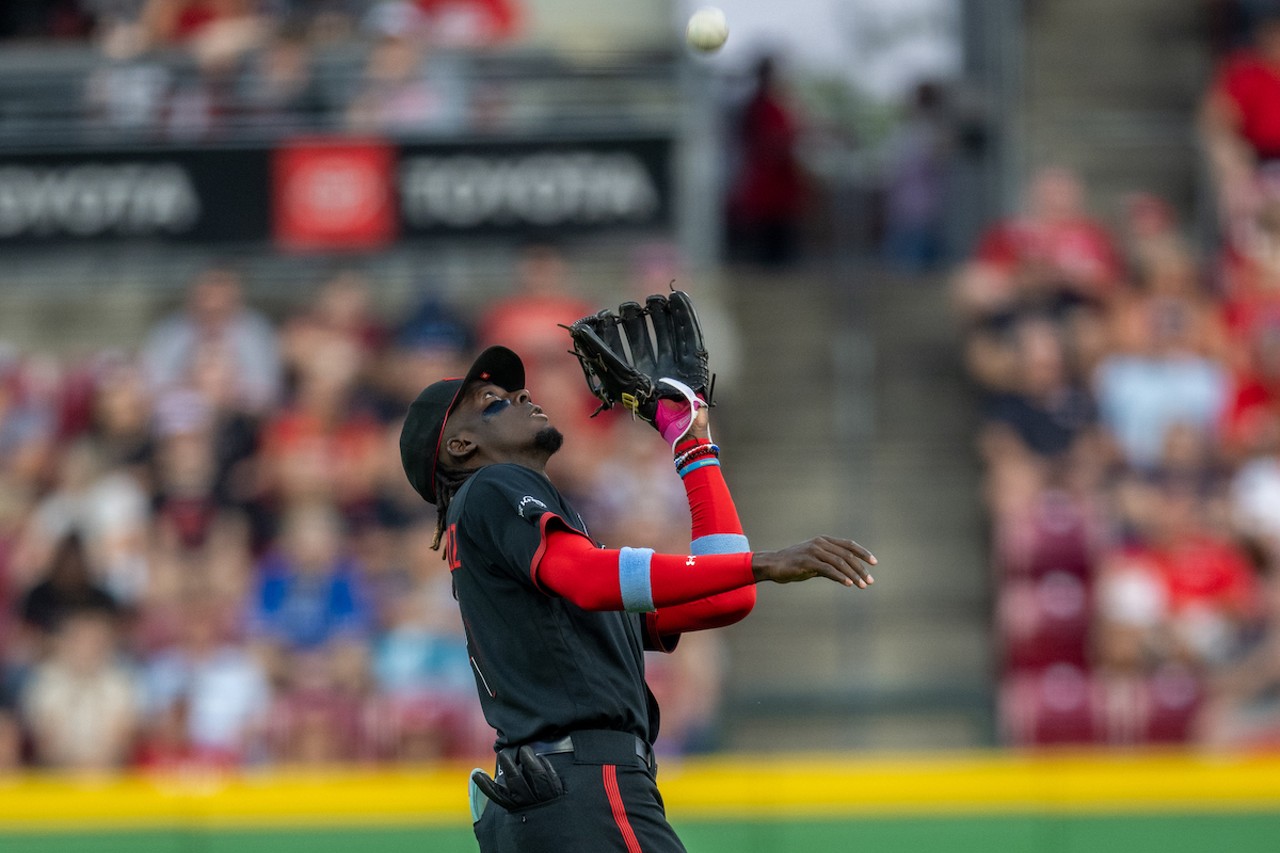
[0,753,1280,853]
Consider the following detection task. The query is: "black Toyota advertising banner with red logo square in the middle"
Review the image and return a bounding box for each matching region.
[0,137,673,245]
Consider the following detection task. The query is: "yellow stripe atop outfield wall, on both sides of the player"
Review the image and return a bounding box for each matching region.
[0,753,1280,831]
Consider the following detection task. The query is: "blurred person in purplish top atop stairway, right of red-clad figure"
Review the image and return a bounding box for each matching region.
[883,82,954,273]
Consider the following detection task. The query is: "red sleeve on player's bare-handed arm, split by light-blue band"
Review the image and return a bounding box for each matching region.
[532,528,755,610]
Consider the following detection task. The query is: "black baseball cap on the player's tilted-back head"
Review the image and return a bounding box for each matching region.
[401,347,525,503]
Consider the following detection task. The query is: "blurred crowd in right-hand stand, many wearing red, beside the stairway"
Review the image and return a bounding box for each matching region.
[954,14,1280,748]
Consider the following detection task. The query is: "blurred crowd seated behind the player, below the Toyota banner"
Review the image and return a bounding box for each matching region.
[0,243,719,770]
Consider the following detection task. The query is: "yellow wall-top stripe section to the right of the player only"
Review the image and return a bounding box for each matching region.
[662,753,1280,816]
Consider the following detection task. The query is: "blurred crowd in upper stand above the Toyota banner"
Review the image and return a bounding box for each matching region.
[0,0,525,142]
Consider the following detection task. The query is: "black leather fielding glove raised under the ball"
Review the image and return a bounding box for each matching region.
[566,291,714,437]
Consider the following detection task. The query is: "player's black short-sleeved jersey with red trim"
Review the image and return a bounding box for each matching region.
[445,464,658,749]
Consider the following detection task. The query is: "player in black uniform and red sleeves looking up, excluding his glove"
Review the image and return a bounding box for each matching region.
[401,346,876,853]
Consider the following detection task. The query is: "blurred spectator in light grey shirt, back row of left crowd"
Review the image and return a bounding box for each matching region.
[142,266,282,414]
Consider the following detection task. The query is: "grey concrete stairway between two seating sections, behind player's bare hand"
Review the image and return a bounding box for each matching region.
[718,262,991,749]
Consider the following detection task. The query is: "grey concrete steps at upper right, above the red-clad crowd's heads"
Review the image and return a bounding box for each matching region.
[1016,0,1212,222]
